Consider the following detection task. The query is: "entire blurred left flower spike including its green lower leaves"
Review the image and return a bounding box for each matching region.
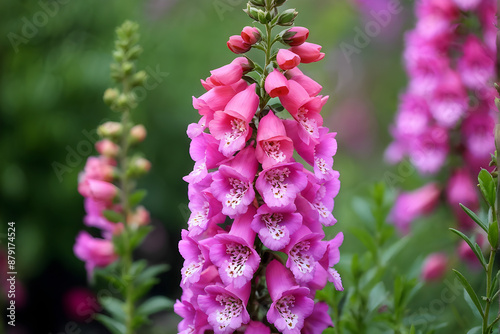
[74,21,172,334]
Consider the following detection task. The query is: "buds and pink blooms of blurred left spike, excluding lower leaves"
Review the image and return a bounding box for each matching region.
[74,22,151,278]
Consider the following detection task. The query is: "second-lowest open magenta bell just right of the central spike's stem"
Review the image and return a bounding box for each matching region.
[285,225,326,284]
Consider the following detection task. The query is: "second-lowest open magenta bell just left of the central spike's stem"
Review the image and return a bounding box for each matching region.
[210,207,260,288]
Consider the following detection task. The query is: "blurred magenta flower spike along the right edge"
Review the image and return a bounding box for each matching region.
[386,0,498,230]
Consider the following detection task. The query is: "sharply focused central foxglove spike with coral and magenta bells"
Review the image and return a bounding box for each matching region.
[174,0,343,334]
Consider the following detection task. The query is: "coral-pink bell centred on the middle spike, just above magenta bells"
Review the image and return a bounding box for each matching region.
[255,110,293,169]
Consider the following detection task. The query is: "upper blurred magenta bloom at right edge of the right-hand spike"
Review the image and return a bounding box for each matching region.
[458,35,495,90]
